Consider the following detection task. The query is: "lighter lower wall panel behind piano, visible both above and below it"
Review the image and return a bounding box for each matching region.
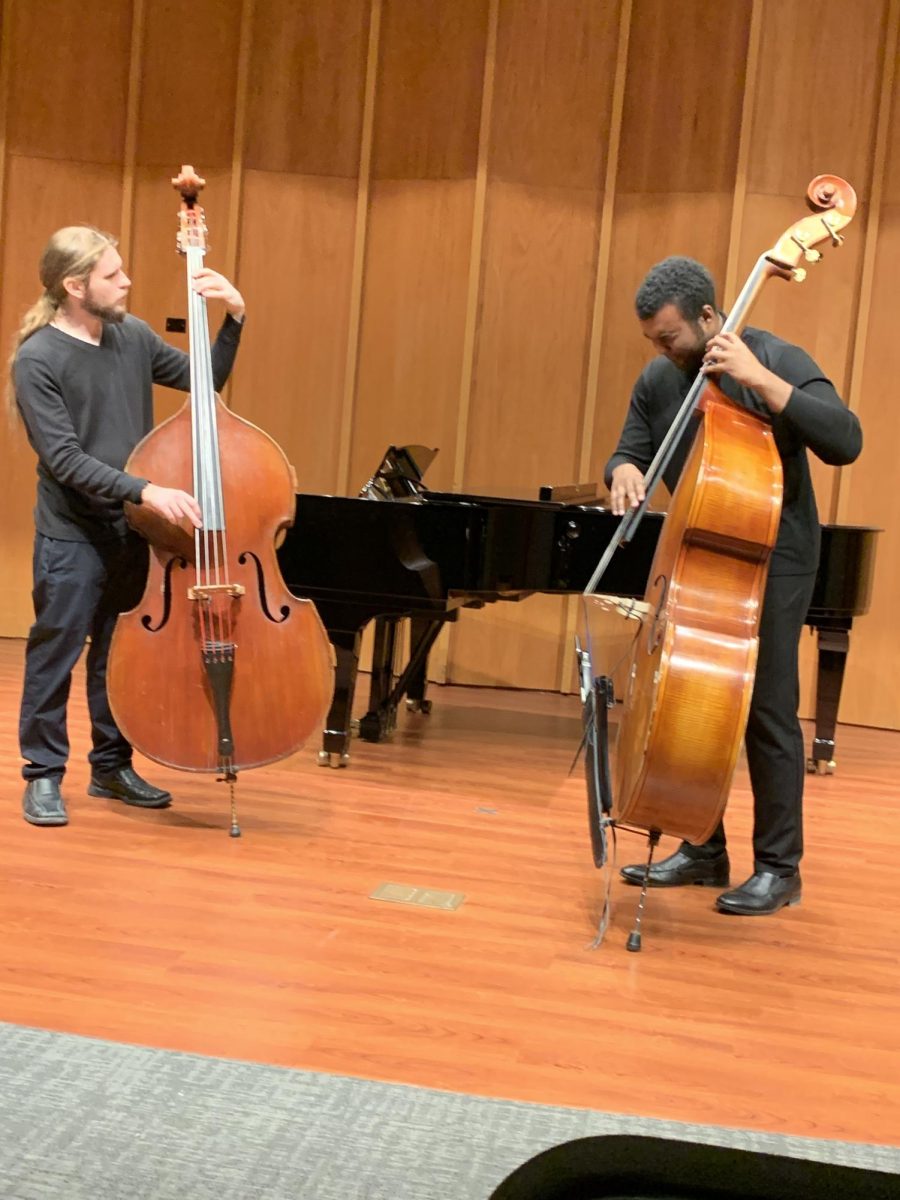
[449,182,607,688]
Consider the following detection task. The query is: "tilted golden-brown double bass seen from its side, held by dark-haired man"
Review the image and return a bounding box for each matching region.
[584,175,857,888]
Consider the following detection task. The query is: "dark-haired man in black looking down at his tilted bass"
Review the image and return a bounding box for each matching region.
[605,250,862,916]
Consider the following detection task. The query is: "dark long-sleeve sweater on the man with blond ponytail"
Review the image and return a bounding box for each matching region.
[14,316,242,541]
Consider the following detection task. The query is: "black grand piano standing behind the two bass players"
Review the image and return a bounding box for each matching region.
[278,446,878,773]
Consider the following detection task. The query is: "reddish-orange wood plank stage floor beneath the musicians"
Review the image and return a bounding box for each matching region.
[0,641,900,1145]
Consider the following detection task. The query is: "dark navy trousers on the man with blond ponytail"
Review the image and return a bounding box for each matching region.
[19,533,146,779]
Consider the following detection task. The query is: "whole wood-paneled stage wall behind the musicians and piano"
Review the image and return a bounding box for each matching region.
[0,0,900,728]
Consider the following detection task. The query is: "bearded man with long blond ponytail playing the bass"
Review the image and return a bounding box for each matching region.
[10,226,244,826]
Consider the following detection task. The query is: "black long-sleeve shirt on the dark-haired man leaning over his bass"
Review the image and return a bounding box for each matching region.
[604,329,863,575]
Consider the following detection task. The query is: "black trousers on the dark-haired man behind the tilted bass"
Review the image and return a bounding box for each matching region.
[685,572,816,875]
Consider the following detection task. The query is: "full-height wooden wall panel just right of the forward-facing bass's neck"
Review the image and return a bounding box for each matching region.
[241,0,371,492]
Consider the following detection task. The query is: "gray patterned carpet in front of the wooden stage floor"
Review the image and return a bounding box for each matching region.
[0,1024,900,1200]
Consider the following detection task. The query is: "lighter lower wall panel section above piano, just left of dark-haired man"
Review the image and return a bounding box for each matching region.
[466,182,596,494]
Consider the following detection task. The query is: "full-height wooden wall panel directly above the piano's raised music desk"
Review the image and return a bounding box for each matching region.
[349,0,487,492]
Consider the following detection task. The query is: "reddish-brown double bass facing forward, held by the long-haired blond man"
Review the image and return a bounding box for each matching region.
[107,167,334,836]
